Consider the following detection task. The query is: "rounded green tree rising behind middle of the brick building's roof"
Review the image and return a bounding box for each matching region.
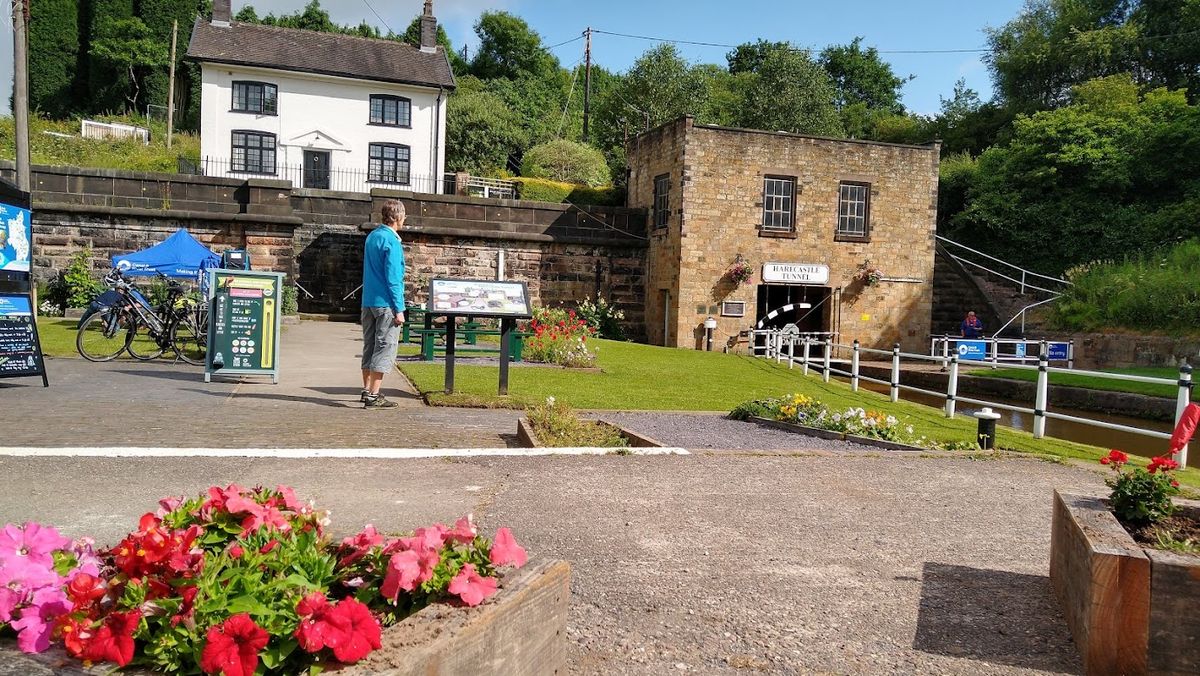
[739,49,842,136]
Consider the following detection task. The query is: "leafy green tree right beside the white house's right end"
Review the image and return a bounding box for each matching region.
[446,76,528,177]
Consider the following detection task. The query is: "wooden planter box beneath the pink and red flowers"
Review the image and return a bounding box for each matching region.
[0,561,571,676]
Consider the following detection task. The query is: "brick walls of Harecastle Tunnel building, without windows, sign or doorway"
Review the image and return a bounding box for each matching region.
[630,119,938,351]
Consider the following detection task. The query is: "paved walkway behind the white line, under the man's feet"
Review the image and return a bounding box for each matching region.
[0,322,517,448]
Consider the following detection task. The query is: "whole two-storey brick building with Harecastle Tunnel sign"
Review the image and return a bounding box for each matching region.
[629,118,938,351]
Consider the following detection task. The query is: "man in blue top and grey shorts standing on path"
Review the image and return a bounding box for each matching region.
[360,199,404,408]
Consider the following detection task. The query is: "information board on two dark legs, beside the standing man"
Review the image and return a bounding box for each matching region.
[425,280,533,395]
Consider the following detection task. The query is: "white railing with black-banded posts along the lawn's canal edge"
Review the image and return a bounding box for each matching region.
[751,329,1192,467]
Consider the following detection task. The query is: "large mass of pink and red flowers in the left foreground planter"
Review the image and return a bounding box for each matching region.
[0,485,526,676]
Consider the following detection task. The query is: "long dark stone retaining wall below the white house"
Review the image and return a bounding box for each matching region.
[9,163,646,336]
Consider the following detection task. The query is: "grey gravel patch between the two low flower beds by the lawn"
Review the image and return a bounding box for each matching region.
[609,413,880,453]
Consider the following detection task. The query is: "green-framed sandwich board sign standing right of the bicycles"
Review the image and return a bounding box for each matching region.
[204,270,283,383]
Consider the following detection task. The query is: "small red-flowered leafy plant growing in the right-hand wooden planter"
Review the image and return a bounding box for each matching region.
[1100,449,1180,528]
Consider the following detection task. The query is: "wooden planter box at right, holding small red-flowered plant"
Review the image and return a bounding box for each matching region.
[1050,491,1200,676]
